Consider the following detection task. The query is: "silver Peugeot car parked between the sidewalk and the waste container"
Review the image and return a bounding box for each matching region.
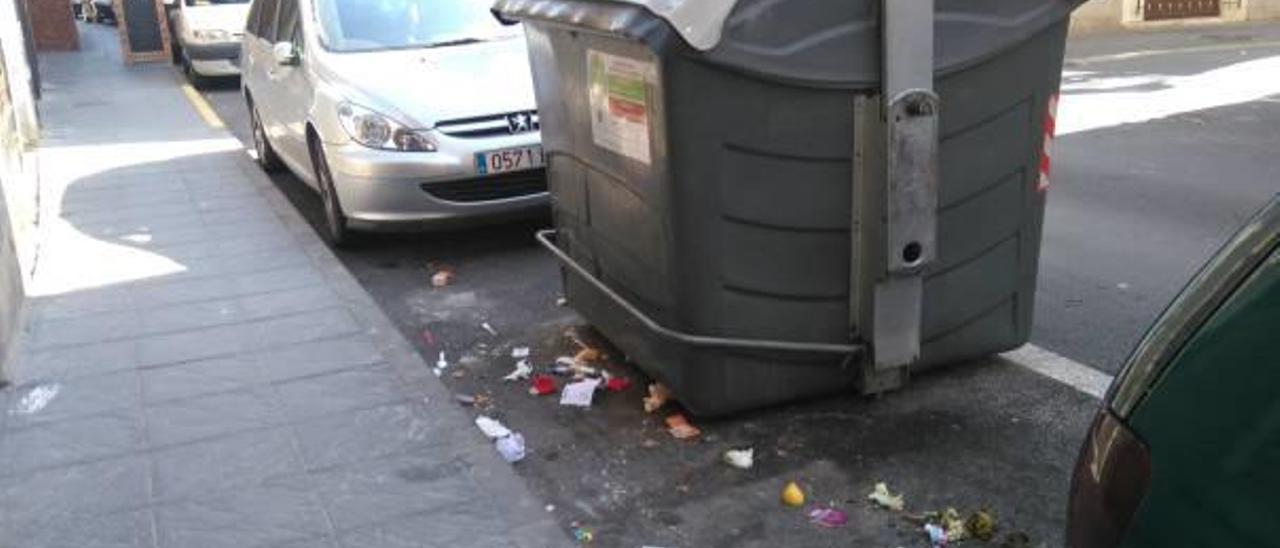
[241,0,549,245]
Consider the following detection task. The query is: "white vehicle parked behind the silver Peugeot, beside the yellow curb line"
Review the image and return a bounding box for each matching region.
[169,0,250,85]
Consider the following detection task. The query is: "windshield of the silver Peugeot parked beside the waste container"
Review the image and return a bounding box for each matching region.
[316,0,520,51]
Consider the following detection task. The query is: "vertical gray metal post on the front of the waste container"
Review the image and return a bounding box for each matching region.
[855,0,940,392]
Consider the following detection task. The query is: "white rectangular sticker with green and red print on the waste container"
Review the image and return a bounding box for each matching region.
[586,50,658,165]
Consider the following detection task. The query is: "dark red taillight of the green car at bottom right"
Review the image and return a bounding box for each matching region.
[1066,408,1151,548]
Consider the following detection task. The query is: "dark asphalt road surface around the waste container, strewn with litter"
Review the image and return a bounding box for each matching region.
[192,27,1280,547]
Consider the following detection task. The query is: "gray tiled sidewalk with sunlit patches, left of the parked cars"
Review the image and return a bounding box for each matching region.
[0,23,560,548]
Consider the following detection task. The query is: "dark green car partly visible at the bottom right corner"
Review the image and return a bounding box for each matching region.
[1066,195,1280,548]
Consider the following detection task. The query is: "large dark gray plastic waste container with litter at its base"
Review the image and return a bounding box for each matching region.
[495,0,1079,415]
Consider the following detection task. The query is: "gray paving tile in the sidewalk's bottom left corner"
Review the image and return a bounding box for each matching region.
[4,510,155,548]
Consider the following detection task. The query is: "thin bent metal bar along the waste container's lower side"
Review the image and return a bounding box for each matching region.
[534,229,867,357]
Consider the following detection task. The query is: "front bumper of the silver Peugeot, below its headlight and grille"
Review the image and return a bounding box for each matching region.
[325,138,550,229]
